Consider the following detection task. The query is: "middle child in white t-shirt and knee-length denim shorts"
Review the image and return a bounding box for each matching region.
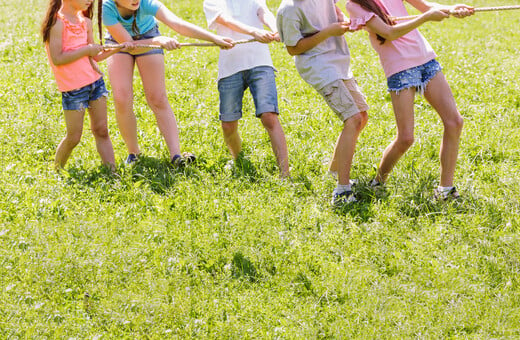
[204,0,289,177]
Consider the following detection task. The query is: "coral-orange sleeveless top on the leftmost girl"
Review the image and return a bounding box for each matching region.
[45,12,102,92]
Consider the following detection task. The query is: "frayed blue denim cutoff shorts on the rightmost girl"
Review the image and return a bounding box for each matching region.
[387,59,442,94]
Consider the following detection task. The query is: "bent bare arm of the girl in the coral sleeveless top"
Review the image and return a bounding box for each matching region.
[49,20,103,65]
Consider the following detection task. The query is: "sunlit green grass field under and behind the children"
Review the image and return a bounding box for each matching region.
[0,0,520,339]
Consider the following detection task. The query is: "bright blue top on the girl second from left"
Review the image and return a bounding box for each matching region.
[103,0,162,36]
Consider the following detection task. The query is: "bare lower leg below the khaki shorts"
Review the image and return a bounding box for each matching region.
[334,111,368,185]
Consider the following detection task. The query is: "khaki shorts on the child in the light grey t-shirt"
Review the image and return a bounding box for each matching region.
[318,78,369,122]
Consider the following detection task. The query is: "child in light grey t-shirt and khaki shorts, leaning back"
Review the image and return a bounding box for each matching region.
[277,0,368,206]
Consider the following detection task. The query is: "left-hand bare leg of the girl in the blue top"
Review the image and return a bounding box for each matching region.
[108,54,140,155]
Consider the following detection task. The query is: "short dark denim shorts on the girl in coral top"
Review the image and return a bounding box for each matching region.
[61,77,108,111]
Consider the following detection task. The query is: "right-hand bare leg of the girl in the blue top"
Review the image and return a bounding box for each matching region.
[136,54,181,158]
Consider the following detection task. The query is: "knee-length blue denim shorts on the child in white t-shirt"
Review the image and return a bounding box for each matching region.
[218,66,278,122]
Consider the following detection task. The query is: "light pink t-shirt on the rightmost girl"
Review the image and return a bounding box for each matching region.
[347,0,437,78]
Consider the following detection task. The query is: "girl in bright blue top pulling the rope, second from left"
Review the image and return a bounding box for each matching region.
[103,0,233,165]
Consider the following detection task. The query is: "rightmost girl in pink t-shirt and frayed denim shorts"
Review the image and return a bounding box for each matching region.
[347,0,474,200]
